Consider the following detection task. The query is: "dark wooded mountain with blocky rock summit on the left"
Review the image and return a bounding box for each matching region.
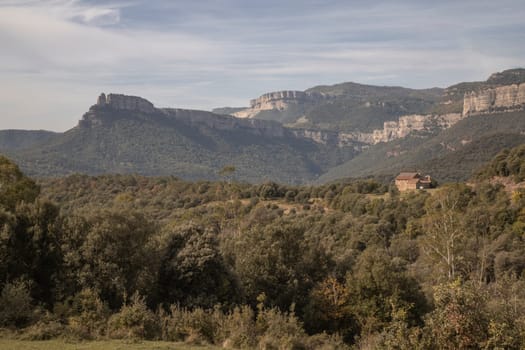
[2,94,356,183]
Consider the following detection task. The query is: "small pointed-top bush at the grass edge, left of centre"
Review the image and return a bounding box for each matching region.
[108,293,160,339]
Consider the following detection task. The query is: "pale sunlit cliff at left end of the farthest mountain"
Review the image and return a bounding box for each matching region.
[233,91,324,118]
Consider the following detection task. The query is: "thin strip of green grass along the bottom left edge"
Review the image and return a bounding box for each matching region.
[0,339,218,350]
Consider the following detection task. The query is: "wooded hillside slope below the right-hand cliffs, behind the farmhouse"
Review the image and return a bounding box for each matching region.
[319,111,525,182]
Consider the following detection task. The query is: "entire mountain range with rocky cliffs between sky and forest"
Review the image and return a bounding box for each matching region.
[0,69,525,184]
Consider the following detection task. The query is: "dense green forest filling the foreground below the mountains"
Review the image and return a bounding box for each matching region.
[0,147,525,349]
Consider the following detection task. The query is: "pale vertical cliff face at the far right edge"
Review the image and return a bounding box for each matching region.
[463,83,525,115]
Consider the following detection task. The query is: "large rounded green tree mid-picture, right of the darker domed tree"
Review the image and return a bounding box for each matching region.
[234,220,329,311]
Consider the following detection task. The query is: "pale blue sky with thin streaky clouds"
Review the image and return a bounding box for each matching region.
[0,0,525,131]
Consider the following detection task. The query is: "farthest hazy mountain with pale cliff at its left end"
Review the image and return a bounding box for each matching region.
[216,69,525,132]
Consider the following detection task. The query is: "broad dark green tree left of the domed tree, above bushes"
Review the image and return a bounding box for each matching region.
[73,211,156,309]
